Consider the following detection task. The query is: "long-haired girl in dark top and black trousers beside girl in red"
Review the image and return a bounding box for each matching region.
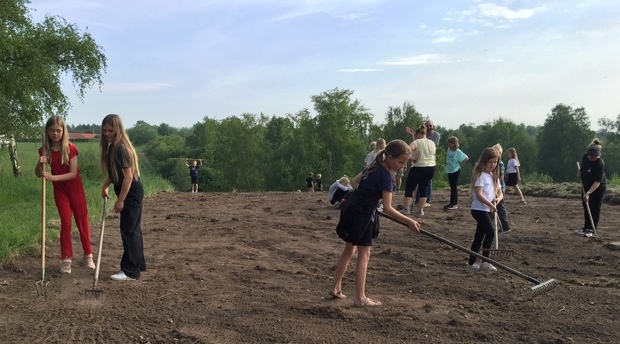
[99,114,146,281]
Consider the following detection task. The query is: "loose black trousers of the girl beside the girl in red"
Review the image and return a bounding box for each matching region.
[114,181,146,278]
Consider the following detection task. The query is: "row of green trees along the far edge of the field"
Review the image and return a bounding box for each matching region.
[71,88,620,191]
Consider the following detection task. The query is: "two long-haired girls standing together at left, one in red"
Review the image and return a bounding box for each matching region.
[35,114,146,281]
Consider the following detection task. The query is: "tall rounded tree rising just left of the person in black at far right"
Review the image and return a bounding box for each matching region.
[538,104,594,182]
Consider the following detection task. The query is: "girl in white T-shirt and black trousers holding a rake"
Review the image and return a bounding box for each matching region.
[465,147,502,272]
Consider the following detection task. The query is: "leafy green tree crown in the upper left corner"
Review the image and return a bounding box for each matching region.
[0,0,107,136]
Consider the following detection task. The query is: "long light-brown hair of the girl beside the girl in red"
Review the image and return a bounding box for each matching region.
[99,114,140,183]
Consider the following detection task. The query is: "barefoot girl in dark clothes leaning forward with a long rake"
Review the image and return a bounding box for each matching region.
[329,140,420,306]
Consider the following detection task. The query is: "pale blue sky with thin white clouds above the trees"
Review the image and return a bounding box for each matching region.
[28,0,620,129]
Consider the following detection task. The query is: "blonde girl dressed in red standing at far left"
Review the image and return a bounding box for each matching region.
[35,116,95,274]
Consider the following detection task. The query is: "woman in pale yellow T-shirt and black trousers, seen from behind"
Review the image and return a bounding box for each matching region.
[400,125,437,216]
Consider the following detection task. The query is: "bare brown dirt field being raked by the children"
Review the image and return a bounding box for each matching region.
[0,191,620,344]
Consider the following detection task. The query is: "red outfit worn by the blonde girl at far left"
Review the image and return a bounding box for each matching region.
[39,143,93,259]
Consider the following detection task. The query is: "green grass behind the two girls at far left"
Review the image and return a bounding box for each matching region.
[0,141,173,261]
